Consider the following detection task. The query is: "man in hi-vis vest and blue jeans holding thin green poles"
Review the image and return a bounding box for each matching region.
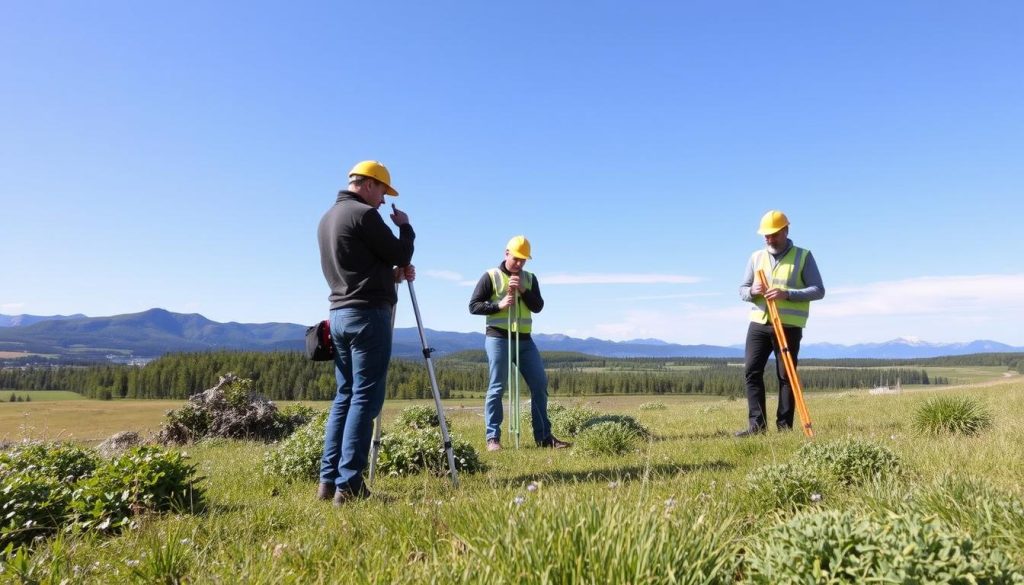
[469,236,570,451]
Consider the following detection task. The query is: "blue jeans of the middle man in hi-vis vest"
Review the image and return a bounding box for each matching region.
[483,337,551,443]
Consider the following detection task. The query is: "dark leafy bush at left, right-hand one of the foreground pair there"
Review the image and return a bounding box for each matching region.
[71,446,203,532]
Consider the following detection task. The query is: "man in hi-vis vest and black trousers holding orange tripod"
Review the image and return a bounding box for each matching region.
[735,210,825,436]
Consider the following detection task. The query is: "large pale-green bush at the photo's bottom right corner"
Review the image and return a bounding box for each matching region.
[743,510,1024,584]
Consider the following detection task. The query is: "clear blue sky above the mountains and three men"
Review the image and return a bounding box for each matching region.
[0,0,1024,345]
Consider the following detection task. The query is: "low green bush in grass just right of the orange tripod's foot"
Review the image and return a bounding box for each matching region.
[796,438,900,486]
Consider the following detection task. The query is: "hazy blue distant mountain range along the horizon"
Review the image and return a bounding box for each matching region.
[0,308,1024,361]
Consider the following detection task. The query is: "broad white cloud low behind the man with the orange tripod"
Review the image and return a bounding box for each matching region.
[548,275,1024,345]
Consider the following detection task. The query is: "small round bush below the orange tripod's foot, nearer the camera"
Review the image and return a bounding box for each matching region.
[746,463,828,509]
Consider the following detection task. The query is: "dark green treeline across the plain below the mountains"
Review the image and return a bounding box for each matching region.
[0,351,947,401]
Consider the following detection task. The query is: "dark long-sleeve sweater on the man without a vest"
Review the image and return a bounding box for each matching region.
[316,191,416,308]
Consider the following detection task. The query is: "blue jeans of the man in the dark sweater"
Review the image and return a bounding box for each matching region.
[321,308,391,493]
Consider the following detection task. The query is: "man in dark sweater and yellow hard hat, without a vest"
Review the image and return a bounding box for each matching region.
[316,161,416,505]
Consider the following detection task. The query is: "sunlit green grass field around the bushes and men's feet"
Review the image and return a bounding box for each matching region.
[0,376,1024,584]
